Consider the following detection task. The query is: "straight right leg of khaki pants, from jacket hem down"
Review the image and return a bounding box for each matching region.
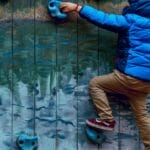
[118,71,150,150]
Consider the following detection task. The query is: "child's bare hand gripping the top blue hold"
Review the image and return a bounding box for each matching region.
[60,2,81,13]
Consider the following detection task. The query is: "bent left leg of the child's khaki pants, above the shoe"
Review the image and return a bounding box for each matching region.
[90,71,127,120]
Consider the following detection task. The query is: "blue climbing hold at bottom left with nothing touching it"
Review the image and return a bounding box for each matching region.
[17,134,38,150]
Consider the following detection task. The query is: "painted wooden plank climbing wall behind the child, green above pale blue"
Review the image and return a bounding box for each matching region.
[0,0,149,150]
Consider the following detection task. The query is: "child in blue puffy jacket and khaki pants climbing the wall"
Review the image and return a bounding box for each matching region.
[60,0,150,150]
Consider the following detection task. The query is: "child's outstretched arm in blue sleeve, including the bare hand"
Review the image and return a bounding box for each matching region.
[60,2,130,32]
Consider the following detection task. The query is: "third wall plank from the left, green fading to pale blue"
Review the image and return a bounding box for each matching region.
[35,0,57,150]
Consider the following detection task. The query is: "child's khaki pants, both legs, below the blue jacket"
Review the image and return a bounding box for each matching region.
[90,70,150,150]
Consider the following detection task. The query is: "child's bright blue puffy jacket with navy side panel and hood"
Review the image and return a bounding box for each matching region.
[80,0,150,81]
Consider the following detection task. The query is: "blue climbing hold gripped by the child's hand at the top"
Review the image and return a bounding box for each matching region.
[48,0,68,20]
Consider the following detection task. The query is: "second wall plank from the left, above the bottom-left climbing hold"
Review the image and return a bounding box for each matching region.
[11,1,35,149]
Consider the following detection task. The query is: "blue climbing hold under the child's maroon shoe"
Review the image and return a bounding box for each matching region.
[86,127,106,144]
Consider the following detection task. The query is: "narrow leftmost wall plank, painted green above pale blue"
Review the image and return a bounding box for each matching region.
[0,0,13,150]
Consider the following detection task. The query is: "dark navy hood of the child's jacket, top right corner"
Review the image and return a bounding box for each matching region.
[123,0,150,18]
